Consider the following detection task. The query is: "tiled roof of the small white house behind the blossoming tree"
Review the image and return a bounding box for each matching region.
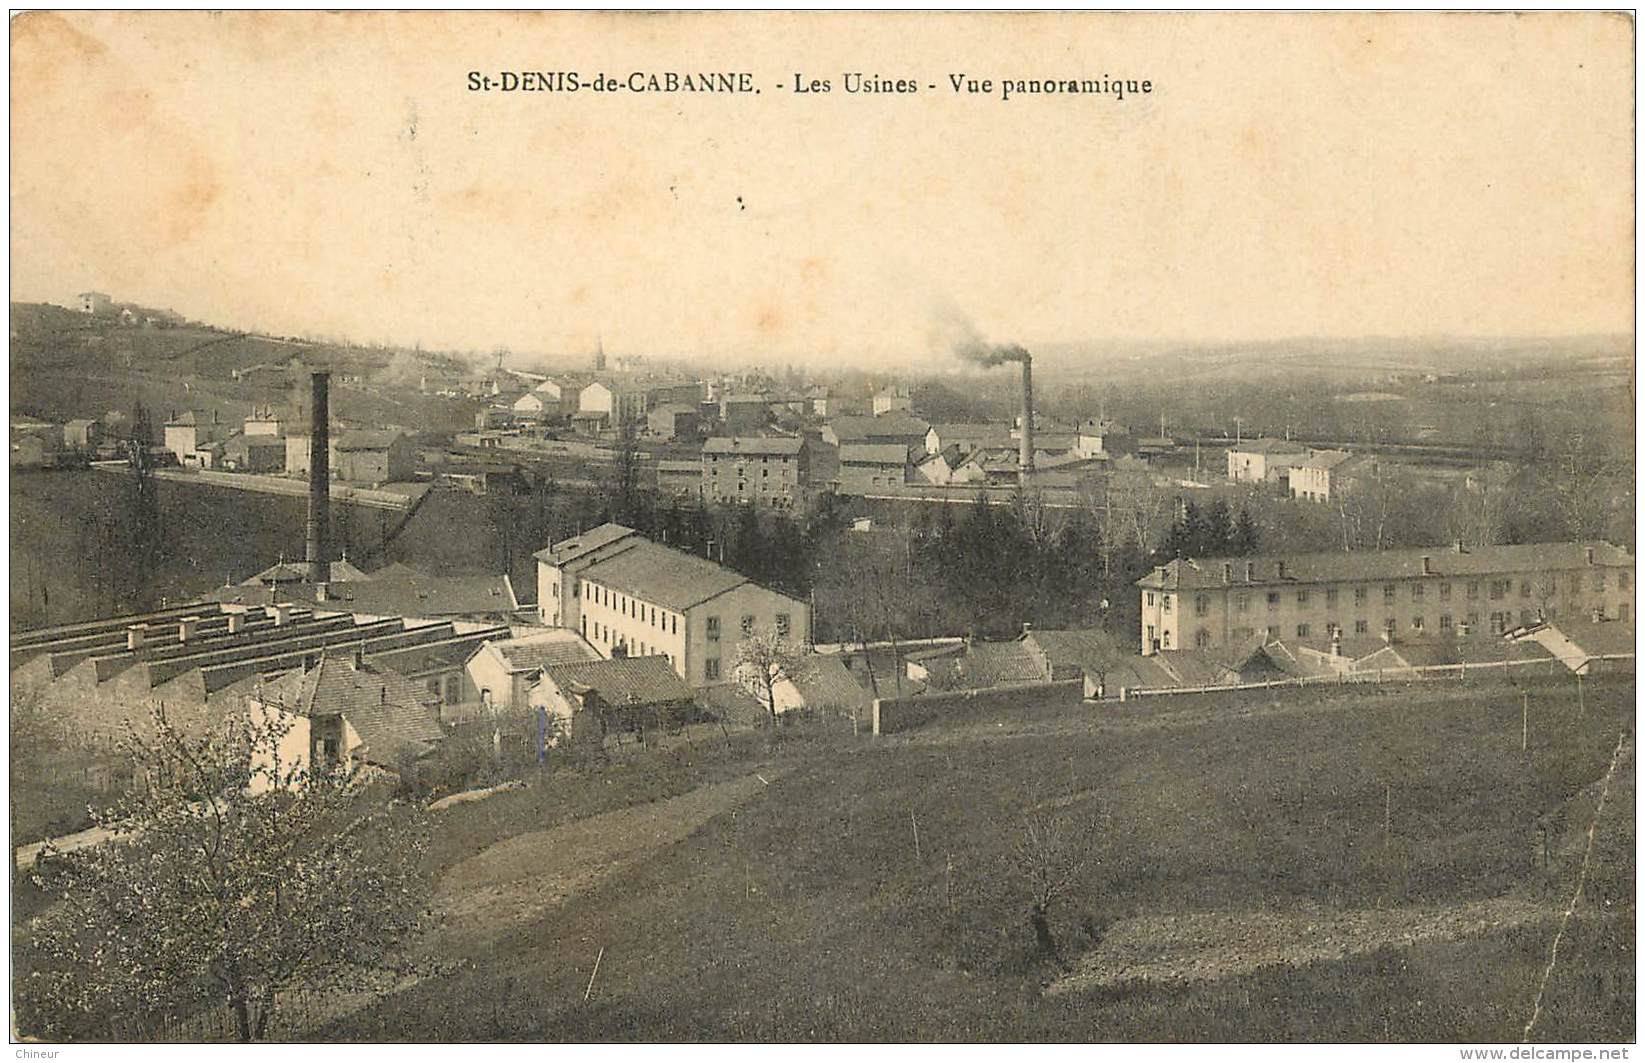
[255,650,444,764]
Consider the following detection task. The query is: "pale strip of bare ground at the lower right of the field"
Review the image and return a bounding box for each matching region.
[1046,897,1558,994]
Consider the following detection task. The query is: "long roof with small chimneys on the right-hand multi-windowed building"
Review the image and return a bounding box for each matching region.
[1137,541,1633,591]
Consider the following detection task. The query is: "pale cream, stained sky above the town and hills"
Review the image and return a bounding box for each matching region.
[10,13,1633,365]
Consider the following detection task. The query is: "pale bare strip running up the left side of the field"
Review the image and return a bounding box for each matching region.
[434,772,776,931]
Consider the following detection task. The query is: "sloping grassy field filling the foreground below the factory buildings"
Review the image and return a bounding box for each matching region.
[314,680,1635,1042]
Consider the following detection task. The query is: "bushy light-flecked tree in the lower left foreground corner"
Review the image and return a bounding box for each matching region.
[21,709,426,1042]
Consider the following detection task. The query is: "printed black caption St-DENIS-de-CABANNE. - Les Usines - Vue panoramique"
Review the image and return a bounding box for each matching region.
[467,71,1153,100]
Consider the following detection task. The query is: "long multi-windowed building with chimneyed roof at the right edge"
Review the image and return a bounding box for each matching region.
[1137,541,1633,653]
